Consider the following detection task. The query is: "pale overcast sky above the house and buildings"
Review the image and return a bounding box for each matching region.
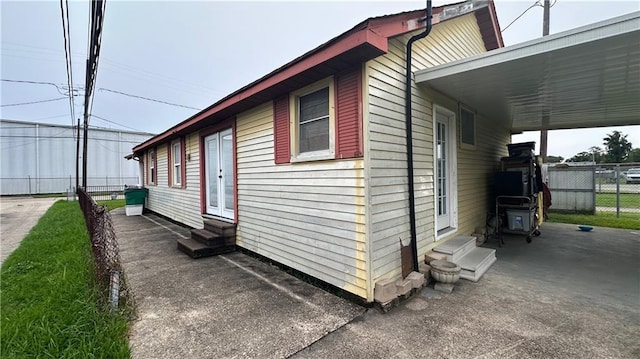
[0,0,640,158]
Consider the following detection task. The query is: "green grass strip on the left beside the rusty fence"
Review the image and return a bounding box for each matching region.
[0,201,130,358]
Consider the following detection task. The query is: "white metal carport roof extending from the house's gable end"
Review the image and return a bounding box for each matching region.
[415,12,640,132]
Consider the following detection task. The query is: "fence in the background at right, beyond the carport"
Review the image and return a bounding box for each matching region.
[545,163,640,220]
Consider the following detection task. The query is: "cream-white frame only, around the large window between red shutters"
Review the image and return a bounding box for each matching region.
[289,76,335,163]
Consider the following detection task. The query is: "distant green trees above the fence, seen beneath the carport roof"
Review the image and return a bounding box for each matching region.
[547,131,640,163]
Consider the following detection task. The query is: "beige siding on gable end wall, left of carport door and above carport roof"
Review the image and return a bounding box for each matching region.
[365,14,485,282]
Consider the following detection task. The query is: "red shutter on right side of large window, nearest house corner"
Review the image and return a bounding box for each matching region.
[336,67,363,158]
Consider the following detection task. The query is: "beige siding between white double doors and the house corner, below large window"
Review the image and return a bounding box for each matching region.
[236,102,370,299]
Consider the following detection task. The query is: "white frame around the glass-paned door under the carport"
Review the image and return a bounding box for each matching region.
[433,104,458,240]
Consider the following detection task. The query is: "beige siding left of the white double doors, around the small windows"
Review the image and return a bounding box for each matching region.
[147,133,203,228]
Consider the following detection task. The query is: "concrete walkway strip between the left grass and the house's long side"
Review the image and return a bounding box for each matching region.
[112,209,365,359]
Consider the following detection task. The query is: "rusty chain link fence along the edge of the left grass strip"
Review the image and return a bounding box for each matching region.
[78,188,131,309]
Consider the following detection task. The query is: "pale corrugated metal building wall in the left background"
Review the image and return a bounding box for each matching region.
[0,120,152,195]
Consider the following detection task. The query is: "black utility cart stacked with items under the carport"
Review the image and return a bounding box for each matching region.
[494,142,542,245]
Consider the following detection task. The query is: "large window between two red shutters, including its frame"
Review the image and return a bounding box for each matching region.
[290,78,334,162]
